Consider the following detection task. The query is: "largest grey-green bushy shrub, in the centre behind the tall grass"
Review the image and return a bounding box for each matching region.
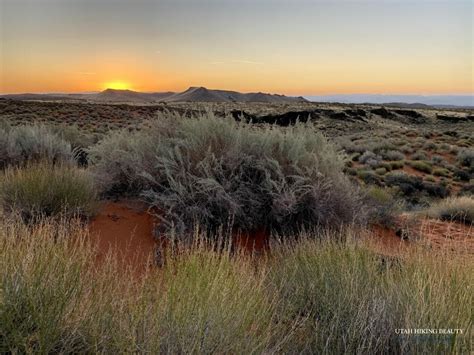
[91,115,363,235]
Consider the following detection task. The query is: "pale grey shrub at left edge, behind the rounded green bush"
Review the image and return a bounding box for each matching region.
[0,125,73,168]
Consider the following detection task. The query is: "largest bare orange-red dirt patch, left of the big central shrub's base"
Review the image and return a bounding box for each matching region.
[89,202,157,272]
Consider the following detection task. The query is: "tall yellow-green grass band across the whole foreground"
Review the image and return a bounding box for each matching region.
[0,220,474,353]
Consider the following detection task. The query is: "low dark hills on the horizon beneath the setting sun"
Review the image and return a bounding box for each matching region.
[0,87,307,103]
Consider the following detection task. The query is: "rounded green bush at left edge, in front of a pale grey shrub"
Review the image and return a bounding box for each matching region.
[0,163,96,221]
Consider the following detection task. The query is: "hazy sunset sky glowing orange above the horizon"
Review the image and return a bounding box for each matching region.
[0,0,474,95]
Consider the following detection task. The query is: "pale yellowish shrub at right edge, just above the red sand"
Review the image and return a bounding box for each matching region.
[427,196,474,224]
